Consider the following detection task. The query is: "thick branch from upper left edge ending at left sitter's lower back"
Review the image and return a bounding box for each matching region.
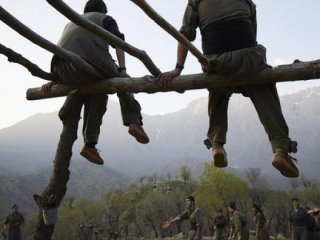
[0,6,102,75]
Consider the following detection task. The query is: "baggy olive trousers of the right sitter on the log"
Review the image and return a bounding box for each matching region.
[204,45,291,152]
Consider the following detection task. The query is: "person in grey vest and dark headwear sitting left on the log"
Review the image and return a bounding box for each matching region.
[42,0,149,165]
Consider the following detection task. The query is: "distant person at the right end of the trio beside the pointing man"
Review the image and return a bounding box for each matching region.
[252,203,269,240]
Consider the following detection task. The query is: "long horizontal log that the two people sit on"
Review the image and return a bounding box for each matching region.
[27,60,320,100]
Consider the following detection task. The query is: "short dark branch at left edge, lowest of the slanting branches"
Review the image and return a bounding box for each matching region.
[0,43,59,81]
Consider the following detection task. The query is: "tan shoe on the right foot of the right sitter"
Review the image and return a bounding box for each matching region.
[272,149,299,178]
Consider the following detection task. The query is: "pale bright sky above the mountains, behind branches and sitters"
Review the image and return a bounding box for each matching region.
[0,0,320,129]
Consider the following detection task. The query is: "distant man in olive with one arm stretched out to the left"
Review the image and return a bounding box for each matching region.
[163,196,202,240]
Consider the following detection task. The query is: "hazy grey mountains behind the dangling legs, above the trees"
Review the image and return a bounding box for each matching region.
[0,88,320,213]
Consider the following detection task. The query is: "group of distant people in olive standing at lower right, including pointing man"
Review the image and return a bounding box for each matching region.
[163,196,320,240]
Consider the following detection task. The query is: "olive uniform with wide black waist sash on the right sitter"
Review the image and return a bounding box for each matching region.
[180,0,298,152]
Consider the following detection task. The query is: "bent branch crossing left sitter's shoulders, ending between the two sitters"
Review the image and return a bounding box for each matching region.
[47,0,160,76]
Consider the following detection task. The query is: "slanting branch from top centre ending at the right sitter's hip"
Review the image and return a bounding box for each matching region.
[130,0,209,66]
